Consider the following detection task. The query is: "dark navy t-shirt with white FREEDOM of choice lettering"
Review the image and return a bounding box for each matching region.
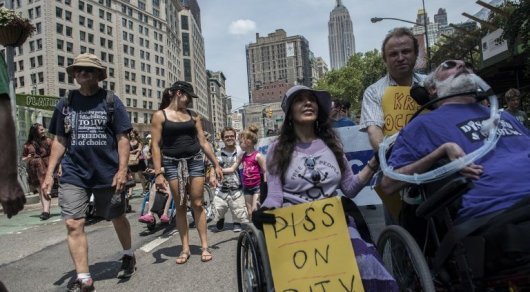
[49,89,132,189]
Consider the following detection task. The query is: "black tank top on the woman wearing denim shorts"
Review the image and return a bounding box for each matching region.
[161,110,201,158]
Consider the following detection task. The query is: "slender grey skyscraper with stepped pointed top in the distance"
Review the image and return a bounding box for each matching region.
[328,0,355,69]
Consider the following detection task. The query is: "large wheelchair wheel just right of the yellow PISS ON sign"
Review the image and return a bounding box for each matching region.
[377,225,435,292]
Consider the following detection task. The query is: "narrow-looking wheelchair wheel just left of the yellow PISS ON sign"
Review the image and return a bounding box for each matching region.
[237,230,266,292]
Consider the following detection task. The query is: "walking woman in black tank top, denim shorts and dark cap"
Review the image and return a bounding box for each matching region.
[151,81,223,264]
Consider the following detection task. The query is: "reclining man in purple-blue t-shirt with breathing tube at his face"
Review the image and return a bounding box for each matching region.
[380,60,530,291]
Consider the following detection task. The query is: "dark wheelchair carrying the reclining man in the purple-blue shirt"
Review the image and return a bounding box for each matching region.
[377,175,530,291]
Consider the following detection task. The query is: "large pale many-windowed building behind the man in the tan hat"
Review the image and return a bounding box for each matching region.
[4,0,208,138]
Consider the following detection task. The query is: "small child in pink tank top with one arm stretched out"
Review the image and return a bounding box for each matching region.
[223,125,267,220]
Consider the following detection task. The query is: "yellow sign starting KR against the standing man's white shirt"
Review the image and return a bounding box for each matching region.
[381,86,420,136]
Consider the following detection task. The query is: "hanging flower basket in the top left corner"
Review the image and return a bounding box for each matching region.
[0,7,35,47]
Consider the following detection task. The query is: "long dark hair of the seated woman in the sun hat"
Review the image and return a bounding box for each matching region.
[268,98,347,185]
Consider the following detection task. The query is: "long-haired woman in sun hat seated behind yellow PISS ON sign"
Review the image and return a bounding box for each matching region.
[252,85,397,291]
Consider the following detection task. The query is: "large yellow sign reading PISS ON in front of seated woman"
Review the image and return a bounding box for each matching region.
[263,197,364,292]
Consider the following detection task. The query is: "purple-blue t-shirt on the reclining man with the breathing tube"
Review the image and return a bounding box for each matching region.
[389,104,530,222]
